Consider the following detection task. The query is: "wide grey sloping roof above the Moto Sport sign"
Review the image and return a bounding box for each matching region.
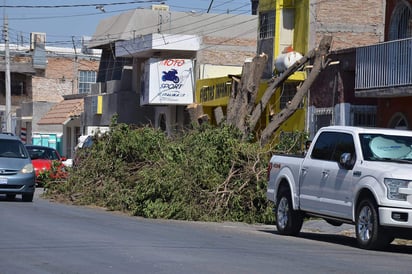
[88,9,258,48]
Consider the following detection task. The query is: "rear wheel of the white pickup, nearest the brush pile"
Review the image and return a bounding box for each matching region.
[275,188,303,236]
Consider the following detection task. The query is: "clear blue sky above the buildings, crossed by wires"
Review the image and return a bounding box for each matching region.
[0,0,251,47]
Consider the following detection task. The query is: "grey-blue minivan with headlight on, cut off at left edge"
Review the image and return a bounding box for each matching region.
[0,134,36,202]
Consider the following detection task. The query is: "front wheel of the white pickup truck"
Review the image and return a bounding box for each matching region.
[355,198,394,249]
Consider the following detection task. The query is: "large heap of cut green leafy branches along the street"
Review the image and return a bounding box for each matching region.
[47,124,308,223]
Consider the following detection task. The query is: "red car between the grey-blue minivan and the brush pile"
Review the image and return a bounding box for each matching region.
[26,145,66,185]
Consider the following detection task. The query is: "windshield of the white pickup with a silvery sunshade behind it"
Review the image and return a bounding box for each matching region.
[359,134,412,163]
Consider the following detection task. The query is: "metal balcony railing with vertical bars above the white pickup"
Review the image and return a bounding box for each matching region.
[355,38,412,91]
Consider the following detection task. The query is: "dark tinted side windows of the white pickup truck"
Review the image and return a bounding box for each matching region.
[311,132,355,162]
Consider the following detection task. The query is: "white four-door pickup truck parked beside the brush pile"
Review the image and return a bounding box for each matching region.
[267,126,412,249]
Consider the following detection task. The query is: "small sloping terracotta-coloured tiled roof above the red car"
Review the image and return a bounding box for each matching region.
[37,98,84,125]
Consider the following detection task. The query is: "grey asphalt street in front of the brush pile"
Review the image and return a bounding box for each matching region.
[0,188,412,274]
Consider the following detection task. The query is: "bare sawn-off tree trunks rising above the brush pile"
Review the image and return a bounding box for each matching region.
[226,36,332,144]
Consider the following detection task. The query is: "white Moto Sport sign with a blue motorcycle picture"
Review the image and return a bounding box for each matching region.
[140,58,194,105]
